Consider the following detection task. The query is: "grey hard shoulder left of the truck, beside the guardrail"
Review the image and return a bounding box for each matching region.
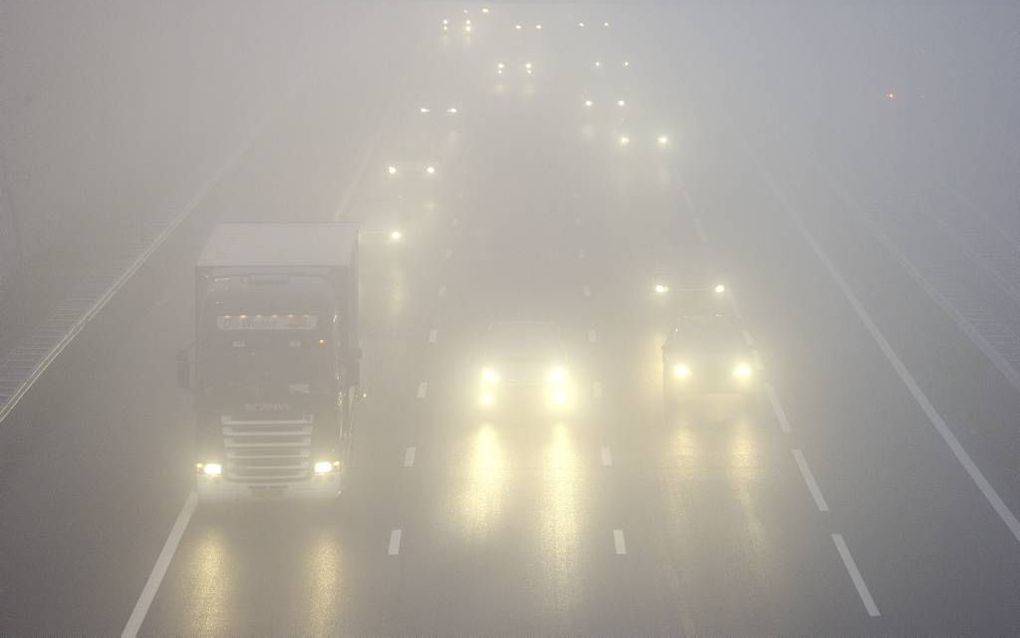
[3,18,426,633]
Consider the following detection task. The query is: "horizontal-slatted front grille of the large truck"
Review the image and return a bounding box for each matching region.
[219,414,314,485]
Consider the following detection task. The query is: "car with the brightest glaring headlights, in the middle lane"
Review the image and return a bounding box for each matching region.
[477,322,573,411]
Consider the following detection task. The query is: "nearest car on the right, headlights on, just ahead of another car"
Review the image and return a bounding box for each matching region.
[662,313,756,405]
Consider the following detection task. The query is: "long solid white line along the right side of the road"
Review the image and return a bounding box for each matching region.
[741,129,1020,541]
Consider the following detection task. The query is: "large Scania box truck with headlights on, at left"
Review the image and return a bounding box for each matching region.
[179,224,361,500]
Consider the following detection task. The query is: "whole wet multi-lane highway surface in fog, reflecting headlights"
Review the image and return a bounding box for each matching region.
[0,4,1020,636]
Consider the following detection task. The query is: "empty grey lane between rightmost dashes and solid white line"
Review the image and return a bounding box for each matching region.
[681,125,1017,632]
